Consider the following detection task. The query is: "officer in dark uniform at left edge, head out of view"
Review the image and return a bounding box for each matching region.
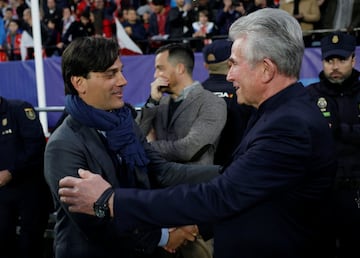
[0,96,51,258]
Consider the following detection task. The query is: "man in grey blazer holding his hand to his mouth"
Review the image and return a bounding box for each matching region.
[139,43,226,164]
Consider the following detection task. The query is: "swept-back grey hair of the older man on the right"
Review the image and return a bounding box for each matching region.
[229,8,304,78]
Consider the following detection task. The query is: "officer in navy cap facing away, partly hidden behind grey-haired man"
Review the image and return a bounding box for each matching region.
[202,39,253,165]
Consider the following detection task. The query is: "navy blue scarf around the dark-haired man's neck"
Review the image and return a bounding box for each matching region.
[65,95,149,171]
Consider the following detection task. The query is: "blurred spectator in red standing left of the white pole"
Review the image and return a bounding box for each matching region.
[6,20,21,60]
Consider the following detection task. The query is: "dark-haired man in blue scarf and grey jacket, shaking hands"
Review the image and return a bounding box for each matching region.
[45,37,219,258]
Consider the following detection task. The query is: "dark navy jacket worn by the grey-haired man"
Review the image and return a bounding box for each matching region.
[114,83,336,258]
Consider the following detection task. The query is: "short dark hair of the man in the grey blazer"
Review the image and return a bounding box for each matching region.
[155,43,195,75]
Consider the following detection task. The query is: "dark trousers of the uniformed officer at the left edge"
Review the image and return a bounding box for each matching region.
[0,181,50,258]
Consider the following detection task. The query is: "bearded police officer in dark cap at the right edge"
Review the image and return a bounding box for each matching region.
[307,32,360,258]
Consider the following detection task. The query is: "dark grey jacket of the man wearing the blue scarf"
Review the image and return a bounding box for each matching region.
[45,116,219,258]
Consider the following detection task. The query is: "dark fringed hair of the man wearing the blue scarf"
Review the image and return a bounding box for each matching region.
[61,37,119,95]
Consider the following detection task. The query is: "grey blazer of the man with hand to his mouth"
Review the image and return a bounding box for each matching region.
[139,82,227,164]
